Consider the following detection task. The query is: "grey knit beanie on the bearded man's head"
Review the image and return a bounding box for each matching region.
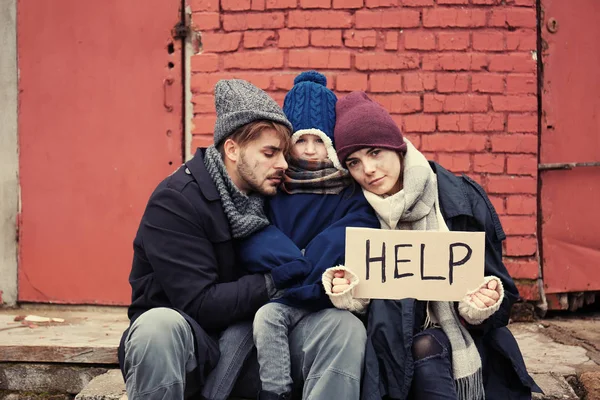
[214,79,293,146]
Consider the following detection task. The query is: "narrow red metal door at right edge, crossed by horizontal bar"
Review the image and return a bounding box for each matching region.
[540,0,600,293]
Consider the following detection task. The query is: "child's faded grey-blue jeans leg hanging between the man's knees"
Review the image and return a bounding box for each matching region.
[253,303,309,394]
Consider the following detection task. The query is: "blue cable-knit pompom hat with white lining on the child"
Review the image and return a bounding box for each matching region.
[283,71,344,169]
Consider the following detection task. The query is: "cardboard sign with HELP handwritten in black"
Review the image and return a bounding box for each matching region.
[346,228,485,301]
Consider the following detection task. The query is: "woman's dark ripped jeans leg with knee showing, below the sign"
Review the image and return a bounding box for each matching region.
[411,328,458,400]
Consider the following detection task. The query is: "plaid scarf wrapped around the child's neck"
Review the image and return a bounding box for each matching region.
[283,158,352,194]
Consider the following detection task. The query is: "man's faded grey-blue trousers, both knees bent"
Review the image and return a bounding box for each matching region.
[124,308,366,400]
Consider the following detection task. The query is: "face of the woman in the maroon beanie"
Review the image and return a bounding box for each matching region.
[346,147,402,196]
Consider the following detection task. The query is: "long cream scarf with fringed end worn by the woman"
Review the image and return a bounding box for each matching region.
[363,141,485,400]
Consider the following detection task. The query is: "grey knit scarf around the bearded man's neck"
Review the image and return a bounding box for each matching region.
[204,146,269,238]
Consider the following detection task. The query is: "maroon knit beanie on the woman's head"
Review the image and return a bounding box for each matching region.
[334,92,406,165]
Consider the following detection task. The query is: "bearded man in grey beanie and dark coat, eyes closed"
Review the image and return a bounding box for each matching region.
[119,80,366,400]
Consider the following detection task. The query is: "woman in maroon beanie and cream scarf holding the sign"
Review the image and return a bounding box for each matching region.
[323,92,539,400]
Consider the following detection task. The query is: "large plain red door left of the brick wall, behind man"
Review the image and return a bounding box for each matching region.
[17,0,183,304]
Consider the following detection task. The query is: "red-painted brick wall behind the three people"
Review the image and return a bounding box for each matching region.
[188,0,538,299]
